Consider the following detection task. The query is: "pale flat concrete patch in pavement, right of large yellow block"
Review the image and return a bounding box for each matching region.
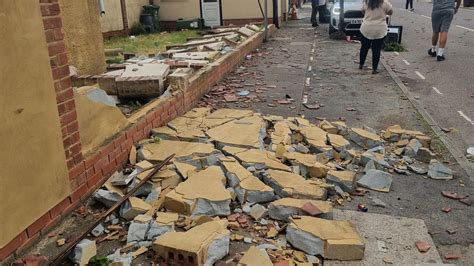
[324,210,442,266]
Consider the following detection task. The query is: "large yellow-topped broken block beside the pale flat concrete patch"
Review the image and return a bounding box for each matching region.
[286,216,365,260]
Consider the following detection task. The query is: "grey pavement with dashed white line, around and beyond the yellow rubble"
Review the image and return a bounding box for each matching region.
[201,5,474,264]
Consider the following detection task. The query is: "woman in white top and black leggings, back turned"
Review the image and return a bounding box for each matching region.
[359,0,393,74]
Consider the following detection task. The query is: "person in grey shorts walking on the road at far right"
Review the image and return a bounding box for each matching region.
[428,0,461,61]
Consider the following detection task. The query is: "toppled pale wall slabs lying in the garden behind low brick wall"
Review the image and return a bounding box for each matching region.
[73,25,261,106]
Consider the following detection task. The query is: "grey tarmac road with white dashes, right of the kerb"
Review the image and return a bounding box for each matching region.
[384,0,474,176]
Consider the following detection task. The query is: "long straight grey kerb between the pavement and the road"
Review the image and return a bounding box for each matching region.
[380,58,474,182]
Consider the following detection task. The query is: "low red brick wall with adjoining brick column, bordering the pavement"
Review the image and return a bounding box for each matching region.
[0,20,276,261]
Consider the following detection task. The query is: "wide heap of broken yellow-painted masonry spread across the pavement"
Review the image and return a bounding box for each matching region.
[68,108,452,265]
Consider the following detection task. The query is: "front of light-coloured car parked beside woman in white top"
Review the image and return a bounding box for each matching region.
[326,0,364,35]
